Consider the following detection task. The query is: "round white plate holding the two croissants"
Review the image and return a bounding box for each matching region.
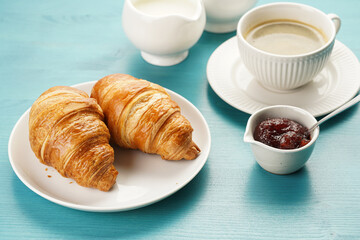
[9,82,211,212]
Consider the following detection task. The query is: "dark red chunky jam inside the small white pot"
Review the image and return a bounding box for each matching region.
[254,118,310,149]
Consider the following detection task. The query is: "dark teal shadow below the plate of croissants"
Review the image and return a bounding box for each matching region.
[13,165,209,239]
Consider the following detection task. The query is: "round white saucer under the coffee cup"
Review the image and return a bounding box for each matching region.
[207,37,360,117]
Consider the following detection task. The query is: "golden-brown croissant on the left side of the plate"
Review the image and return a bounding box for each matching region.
[29,86,118,191]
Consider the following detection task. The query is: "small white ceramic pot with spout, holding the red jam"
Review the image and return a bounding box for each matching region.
[244,105,320,174]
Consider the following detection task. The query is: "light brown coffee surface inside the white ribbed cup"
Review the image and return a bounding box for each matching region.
[244,19,327,55]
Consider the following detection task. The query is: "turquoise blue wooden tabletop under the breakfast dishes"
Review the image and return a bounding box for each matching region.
[0,0,360,239]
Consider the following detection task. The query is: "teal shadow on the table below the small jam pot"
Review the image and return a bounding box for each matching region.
[245,163,312,209]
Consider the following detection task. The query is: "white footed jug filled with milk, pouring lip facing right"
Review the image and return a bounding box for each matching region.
[122,0,206,66]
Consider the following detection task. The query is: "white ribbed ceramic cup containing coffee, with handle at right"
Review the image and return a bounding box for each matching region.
[237,2,341,91]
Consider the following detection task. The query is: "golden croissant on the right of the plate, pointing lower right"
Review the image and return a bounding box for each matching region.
[91,74,200,160]
